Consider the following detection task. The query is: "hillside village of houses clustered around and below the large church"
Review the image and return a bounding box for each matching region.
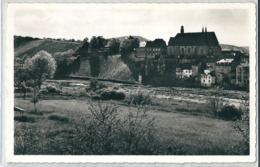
[132,26,249,90]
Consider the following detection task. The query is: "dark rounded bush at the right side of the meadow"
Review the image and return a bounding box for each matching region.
[218,105,243,120]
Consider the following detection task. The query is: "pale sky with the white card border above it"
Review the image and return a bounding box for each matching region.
[10,3,254,46]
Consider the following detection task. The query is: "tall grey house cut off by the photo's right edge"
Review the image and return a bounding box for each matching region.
[236,63,249,87]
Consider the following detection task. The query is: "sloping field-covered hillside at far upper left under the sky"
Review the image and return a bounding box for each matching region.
[14,36,82,57]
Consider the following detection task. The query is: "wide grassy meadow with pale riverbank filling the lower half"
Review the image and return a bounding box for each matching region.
[14,80,248,155]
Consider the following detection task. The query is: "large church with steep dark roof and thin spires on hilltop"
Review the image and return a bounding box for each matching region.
[167,26,221,59]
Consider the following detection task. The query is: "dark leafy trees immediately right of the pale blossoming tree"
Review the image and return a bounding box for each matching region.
[54,49,77,78]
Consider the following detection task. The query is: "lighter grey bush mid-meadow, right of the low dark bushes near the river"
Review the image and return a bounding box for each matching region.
[128,91,152,105]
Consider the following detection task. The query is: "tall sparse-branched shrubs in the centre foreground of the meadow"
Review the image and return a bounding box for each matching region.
[72,103,156,155]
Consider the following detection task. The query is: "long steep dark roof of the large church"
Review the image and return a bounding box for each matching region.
[168,32,219,46]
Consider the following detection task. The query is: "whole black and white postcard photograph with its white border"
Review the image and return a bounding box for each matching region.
[3,3,256,164]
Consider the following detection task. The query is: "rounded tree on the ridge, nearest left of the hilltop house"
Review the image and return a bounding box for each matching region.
[120,37,140,53]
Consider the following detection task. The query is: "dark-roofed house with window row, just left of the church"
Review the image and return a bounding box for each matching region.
[145,39,166,58]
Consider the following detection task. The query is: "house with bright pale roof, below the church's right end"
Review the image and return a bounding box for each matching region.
[215,59,237,83]
